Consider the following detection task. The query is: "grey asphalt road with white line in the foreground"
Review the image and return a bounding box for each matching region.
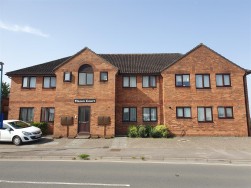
[0,161,251,188]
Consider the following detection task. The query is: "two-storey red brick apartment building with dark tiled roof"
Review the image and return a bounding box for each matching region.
[6,44,251,137]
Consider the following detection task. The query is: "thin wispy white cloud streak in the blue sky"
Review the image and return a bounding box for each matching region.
[0,21,49,38]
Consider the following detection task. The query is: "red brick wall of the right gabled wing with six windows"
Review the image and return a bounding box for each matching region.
[162,46,248,136]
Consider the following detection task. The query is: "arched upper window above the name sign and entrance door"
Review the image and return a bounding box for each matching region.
[78,64,93,86]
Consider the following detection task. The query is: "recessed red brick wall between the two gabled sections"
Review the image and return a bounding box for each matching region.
[116,75,163,135]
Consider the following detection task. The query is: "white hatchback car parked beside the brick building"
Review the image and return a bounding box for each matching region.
[0,120,42,146]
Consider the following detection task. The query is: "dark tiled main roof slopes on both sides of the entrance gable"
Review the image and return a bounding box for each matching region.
[6,53,182,76]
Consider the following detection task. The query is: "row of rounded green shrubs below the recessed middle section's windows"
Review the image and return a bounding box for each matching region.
[128,125,174,138]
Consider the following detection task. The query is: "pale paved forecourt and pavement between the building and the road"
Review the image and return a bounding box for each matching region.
[0,136,251,165]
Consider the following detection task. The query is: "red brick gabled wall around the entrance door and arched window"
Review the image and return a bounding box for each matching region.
[54,49,117,137]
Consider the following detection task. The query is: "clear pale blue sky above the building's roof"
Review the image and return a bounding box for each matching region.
[0,0,251,107]
